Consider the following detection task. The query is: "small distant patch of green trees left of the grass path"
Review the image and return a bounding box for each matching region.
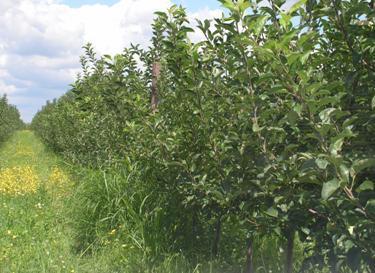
[0,95,23,143]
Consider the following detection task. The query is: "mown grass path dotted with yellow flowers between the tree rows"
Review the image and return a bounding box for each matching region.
[0,131,84,273]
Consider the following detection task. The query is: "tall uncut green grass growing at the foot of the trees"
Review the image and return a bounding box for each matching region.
[69,159,312,273]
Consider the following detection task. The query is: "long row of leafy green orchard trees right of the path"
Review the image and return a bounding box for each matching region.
[32,0,375,272]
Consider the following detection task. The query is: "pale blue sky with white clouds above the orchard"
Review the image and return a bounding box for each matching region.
[0,0,222,122]
